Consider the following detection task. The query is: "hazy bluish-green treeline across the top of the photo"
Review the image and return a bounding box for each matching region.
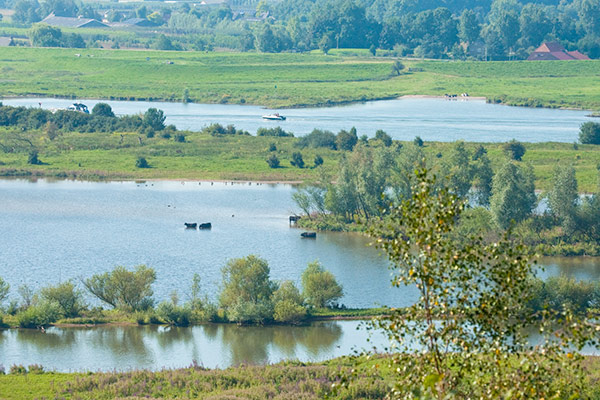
[2,0,600,60]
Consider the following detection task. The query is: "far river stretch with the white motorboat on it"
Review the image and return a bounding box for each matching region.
[1,98,592,143]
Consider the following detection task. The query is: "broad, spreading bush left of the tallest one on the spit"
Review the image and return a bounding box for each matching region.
[82,265,156,311]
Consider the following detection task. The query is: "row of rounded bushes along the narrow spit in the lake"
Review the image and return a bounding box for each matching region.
[0,255,343,328]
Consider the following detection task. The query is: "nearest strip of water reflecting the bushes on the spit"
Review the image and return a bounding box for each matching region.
[0,321,384,371]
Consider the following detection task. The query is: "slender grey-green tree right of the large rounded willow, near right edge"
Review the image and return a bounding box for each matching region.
[548,165,579,234]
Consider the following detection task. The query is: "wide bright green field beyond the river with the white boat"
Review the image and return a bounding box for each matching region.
[0,47,600,110]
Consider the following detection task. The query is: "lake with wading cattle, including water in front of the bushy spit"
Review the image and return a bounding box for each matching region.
[0,179,600,370]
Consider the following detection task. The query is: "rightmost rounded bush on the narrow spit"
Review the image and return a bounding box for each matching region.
[302,261,344,308]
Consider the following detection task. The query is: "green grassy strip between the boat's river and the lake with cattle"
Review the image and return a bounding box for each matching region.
[0,127,600,192]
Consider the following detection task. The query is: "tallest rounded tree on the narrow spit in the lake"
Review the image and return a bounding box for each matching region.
[219,255,277,323]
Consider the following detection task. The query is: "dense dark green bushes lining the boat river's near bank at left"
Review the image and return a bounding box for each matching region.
[0,103,171,134]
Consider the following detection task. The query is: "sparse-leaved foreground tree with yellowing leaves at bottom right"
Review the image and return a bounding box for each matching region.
[369,167,595,399]
